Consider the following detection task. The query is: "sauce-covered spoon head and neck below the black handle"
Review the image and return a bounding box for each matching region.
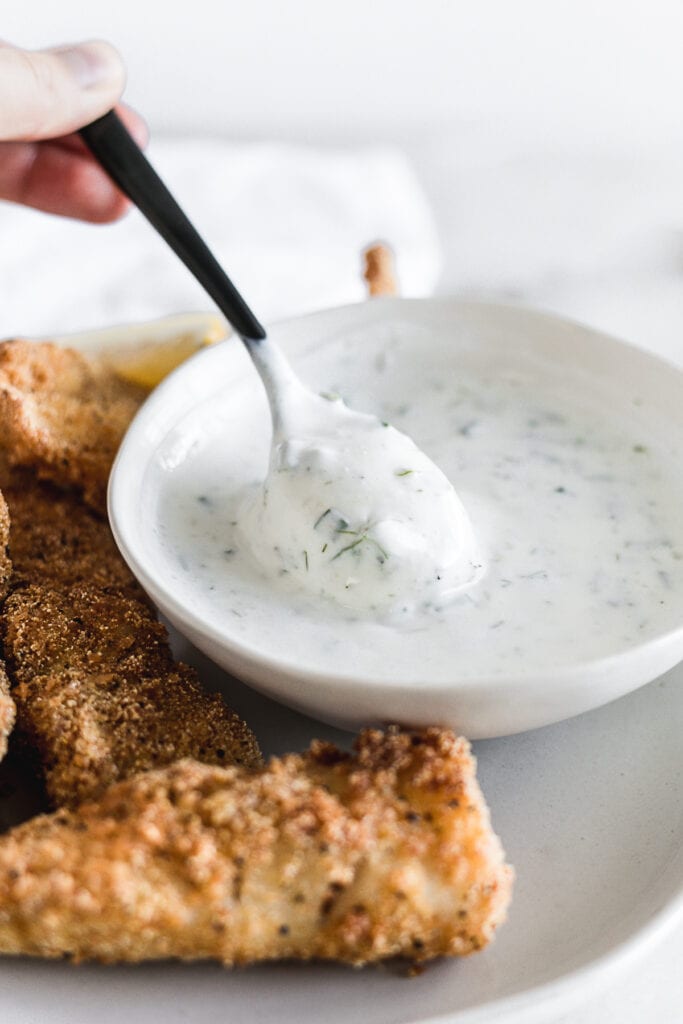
[238,342,482,614]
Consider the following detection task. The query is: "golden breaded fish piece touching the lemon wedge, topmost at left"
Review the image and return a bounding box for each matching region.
[0,339,145,511]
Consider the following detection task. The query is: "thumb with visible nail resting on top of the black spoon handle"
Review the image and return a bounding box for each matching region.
[0,42,125,140]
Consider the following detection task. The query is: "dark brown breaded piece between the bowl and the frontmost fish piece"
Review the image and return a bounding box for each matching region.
[2,584,260,807]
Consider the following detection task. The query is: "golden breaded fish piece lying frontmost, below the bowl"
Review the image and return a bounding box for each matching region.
[0,729,512,965]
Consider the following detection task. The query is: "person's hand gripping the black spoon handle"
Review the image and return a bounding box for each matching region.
[0,42,146,223]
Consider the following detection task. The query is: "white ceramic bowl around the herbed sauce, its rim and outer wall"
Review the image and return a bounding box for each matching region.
[110,299,683,738]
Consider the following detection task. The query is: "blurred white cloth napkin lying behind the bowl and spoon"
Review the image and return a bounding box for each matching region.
[0,139,439,337]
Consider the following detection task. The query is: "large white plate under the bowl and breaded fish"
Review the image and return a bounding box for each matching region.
[0,630,683,1024]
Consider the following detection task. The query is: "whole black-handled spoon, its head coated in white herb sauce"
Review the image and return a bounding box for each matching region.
[80,111,482,614]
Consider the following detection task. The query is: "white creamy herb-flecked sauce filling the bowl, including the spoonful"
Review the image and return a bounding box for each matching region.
[153,325,683,683]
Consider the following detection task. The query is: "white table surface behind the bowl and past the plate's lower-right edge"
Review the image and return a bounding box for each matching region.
[411,127,683,1024]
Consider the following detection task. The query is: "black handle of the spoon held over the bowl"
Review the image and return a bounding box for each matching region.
[79,111,265,342]
